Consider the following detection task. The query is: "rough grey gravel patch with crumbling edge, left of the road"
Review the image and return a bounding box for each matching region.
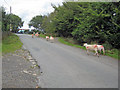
[2,49,40,88]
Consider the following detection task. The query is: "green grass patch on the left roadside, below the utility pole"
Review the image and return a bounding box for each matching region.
[2,34,23,54]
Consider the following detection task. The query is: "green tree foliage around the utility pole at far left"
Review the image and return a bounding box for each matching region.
[0,7,24,32]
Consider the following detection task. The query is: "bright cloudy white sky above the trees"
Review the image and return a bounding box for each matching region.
[0,0,63,29]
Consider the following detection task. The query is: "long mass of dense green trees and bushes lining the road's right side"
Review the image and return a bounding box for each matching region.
[28,1,120,59]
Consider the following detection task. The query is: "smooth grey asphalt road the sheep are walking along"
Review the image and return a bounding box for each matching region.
[18,34,118,88]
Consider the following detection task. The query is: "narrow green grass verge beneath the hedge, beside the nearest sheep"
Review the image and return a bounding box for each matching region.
[58,37,119,59]
